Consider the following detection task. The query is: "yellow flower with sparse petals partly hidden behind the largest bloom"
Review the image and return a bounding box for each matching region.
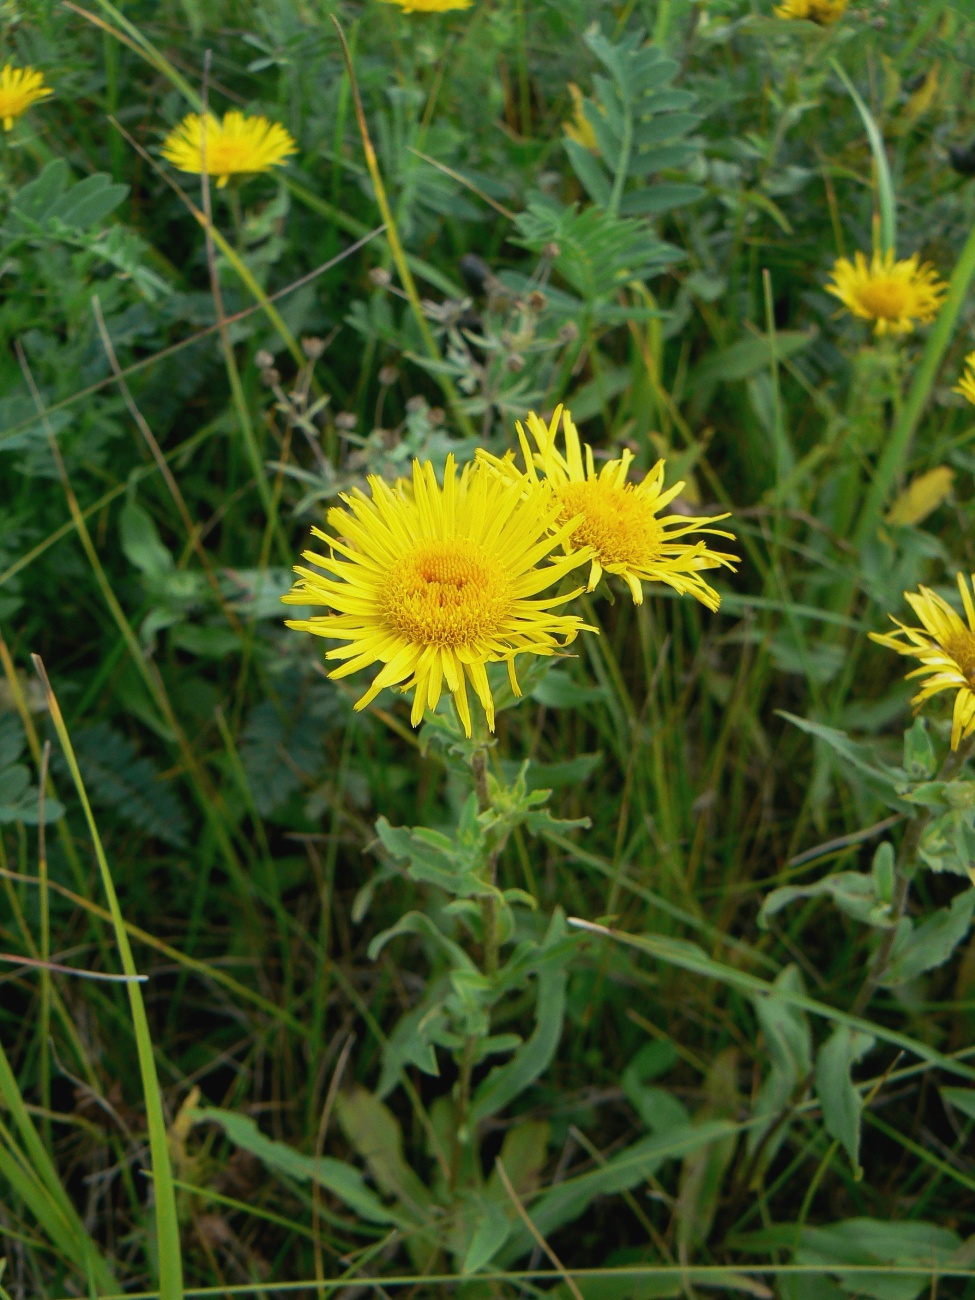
[477,407,737,610]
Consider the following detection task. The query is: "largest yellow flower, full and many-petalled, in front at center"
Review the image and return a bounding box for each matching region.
[283,456,594,736]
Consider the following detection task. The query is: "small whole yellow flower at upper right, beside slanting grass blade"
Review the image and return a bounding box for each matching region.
[826,248,948,334]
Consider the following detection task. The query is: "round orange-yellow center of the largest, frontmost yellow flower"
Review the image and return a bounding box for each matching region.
[380,537,511,647]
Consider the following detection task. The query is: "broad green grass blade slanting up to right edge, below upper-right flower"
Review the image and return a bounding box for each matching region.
[853,213,975,549]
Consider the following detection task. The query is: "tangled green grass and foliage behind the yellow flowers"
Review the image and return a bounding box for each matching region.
[0,0,975,1300]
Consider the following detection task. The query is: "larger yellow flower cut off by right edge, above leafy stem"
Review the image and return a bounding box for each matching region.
[870,573,975,749]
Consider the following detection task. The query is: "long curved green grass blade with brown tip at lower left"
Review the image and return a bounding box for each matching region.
[31,655,183,1300]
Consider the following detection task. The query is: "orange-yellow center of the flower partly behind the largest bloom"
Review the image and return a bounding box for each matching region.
[559,478,663,564]
